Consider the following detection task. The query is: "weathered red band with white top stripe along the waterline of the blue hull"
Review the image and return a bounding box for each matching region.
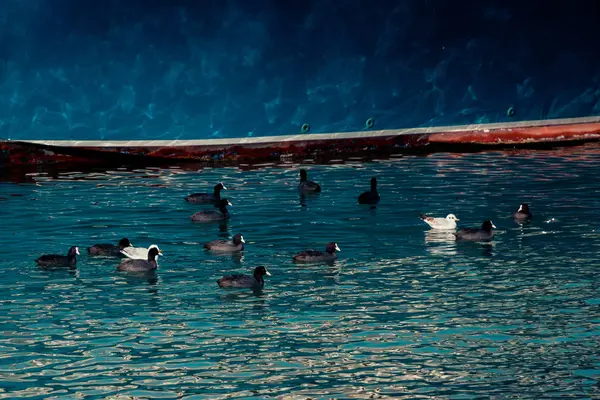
[0,117,600,166]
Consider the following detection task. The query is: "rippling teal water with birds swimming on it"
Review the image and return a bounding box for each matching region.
[0,145,600,399]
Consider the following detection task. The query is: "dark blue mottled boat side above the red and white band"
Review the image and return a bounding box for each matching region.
[0,0,600,139]
